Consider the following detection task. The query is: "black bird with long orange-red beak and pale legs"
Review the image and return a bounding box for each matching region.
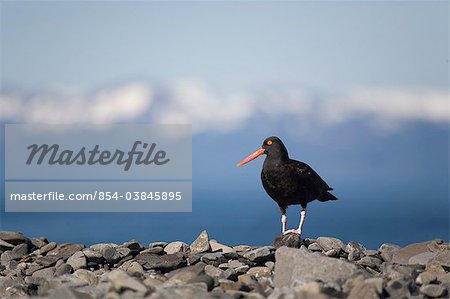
[236,136,337,235]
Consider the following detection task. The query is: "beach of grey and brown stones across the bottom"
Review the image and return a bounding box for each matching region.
[0,231,450,299]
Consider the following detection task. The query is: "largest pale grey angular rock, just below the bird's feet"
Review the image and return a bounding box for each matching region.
[274,247,368,287]
